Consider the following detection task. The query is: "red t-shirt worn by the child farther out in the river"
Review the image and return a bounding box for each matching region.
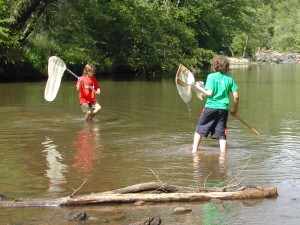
[76,75,100,105]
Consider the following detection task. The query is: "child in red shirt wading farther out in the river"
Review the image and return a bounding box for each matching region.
[76,64,101,122]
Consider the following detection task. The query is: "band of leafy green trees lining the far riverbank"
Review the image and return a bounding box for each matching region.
[0,0,300,79]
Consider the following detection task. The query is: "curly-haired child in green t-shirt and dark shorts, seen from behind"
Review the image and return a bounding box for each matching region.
[192,55,239,153]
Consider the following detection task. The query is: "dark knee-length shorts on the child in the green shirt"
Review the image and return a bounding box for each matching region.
[195,108,228,140]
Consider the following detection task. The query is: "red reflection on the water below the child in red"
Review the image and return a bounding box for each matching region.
[72,123,100,172]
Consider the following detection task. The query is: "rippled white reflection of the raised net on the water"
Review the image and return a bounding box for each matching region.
[42,137,68,192]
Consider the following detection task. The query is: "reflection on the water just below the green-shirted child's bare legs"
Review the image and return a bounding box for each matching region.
[193,150,227,186]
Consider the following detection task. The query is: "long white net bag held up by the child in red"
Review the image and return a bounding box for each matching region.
[44,56,66,101]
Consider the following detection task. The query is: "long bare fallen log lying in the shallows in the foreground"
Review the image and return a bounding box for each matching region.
[0,182,278,208]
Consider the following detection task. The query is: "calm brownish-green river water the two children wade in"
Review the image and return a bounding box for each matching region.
[0,64,300,224]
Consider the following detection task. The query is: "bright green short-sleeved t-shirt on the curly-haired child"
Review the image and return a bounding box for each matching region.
[205,72,238,110]
